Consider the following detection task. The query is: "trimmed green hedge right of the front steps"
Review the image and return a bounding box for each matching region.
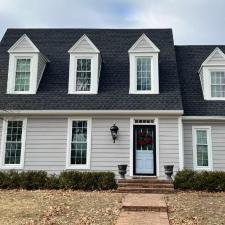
[174,170,225,191]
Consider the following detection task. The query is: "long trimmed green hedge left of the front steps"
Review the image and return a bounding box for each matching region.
[0,171,117,191]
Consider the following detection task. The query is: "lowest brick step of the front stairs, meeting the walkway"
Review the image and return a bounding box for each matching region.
[117,187,174,194]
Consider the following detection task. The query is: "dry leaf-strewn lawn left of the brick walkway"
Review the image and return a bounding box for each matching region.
[0,190,123,225]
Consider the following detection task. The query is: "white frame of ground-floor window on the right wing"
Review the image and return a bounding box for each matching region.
[192,126,213,170]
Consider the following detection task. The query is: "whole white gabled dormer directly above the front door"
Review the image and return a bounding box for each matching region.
[128,34,160,94]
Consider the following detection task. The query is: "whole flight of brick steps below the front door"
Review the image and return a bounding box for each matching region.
[117,177,174,194]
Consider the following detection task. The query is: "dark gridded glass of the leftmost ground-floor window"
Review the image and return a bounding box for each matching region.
[5,121,23,164]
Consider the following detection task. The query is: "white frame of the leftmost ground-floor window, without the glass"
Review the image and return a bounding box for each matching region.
[0,117,27,170]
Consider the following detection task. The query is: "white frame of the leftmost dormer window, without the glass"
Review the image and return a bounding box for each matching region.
[7,53,38,94]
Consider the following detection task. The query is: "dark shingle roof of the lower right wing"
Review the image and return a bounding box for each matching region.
[175,46,225,116]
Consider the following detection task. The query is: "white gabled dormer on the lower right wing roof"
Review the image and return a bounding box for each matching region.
[199,47,225,100]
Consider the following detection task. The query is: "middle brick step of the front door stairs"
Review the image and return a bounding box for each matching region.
[118,182,173,188]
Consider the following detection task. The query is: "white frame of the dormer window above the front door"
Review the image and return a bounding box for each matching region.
[129,52,159,94]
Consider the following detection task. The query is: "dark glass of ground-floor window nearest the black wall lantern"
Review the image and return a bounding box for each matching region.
[70,121,87,164]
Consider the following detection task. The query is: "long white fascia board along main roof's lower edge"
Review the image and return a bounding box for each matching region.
[0,110,184,116]
